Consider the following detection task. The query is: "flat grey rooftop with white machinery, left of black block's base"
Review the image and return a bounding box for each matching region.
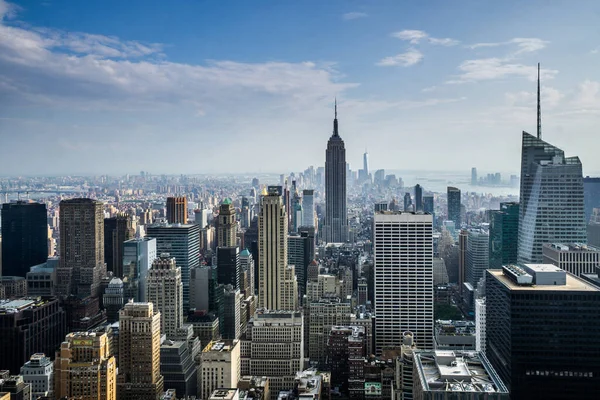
[414,350,508,393]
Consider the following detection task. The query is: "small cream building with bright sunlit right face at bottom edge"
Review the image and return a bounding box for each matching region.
[198,340,241,399]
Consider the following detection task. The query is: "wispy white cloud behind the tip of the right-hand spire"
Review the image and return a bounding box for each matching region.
[446,58,558,84]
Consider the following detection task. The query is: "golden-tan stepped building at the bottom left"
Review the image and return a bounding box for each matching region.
[54,332,117,400]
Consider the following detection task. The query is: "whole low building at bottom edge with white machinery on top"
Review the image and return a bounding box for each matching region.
[413,350,509,400]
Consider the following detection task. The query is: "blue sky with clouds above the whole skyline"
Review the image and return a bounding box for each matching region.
[0,0,600,176]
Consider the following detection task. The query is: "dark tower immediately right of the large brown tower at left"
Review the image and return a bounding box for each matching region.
[104,215,135,278]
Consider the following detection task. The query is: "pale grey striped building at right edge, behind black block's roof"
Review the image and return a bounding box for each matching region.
[542,243,600,277]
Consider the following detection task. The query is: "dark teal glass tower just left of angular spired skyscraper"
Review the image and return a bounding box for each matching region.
[489,203,519,269]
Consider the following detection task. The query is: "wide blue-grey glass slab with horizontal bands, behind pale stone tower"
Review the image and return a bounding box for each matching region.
[147,224,200,312]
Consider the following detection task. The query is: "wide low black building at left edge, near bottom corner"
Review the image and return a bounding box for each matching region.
[0,297,67,374]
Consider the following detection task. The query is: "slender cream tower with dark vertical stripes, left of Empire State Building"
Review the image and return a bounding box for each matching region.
[258,186,298,310]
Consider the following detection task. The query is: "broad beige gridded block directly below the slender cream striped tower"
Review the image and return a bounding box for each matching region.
[241,310,304,398]
